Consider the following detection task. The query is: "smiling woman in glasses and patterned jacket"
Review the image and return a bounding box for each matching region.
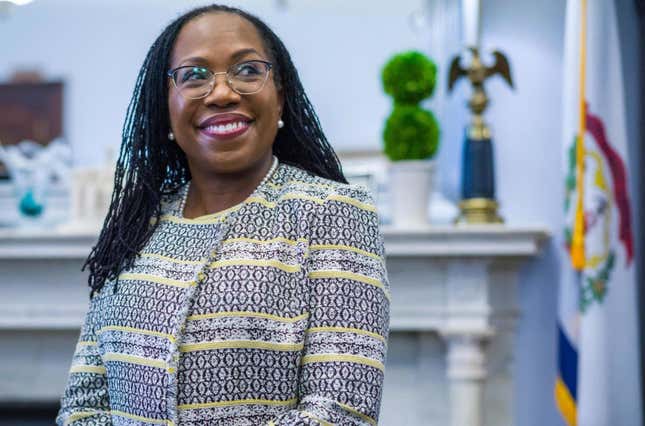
[57,6,389,425]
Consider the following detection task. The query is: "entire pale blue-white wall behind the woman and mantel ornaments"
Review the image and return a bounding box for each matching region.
[0,0,638,426]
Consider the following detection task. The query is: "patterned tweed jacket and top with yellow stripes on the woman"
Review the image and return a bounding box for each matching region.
[57,164,390,426]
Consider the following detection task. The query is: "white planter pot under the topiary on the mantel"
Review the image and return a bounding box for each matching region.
[389,160,435,228]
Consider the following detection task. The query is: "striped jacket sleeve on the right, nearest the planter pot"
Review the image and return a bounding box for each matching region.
[269,189,390,426]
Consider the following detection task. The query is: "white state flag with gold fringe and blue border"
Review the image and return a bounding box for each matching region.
[555,0,642,426]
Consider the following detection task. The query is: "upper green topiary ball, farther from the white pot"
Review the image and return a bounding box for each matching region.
[381,50,437,104]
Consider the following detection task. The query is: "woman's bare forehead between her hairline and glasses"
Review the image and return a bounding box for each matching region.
[170,12,267,66]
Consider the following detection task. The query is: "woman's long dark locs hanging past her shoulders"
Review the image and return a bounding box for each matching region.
[83,5,347,295]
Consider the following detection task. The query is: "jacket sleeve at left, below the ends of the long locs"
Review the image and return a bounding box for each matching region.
[56,296,112,426]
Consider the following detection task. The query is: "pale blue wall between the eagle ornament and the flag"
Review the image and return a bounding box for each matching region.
[482,0,566,426]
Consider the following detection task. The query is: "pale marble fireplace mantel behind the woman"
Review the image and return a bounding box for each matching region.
[0,225,549,426]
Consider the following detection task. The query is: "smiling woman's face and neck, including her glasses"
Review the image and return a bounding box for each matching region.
[168,13,284,195]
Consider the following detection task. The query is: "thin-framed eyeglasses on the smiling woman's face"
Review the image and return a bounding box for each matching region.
[168,60,273,99]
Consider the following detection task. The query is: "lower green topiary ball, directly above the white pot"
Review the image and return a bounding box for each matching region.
[383,105,439,161]
